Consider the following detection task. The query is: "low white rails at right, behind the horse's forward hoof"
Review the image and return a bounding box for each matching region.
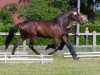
[64,52,100,57]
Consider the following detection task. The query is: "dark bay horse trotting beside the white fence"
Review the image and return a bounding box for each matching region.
[5,8,85,59]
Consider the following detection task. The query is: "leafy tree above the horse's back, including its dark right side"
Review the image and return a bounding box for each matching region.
[19,0,67,20]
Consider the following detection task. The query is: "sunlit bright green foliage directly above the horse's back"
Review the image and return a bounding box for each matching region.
[19,0,61,20]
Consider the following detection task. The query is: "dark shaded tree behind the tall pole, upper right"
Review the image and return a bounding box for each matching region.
[68,0,95,23]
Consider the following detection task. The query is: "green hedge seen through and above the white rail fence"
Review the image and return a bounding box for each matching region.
[0,24,100,45]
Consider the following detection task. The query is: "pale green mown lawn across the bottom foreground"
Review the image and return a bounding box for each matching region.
[0,56,100,75]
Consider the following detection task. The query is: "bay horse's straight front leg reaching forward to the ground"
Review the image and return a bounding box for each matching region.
[62,35,79,60]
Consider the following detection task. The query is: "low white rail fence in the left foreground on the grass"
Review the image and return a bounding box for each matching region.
[0,52,53,64]
